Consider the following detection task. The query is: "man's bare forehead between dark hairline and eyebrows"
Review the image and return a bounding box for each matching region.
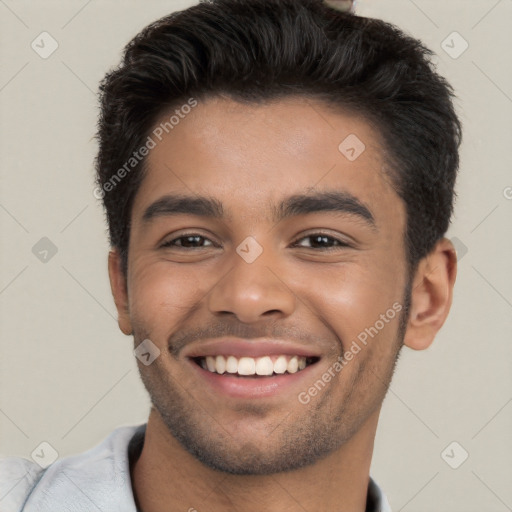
[130,98,401,224]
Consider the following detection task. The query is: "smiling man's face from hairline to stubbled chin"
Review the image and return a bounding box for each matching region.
[120,98,407,474]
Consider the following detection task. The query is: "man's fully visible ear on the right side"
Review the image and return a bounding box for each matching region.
[404,238,457,350]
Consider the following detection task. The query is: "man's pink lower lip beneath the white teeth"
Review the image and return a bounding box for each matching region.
[189,360,318,398]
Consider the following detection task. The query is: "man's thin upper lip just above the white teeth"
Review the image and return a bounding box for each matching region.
[184,338,320,358]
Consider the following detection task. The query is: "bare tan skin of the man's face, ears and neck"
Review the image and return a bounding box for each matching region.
[109,98,456,512]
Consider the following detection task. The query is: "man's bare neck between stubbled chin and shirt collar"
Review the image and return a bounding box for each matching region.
[132,409,379,512]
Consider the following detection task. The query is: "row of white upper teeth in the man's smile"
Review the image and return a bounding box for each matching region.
[201,356,306,375]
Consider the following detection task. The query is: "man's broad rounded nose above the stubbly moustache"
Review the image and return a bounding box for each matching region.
[208,245,297,324]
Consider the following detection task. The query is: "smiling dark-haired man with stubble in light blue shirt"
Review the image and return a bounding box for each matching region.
[2,0,460,512]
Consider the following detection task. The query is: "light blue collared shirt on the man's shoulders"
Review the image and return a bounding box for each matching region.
[0,423,391,512]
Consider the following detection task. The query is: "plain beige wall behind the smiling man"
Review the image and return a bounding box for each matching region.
[0,0,512,512]
